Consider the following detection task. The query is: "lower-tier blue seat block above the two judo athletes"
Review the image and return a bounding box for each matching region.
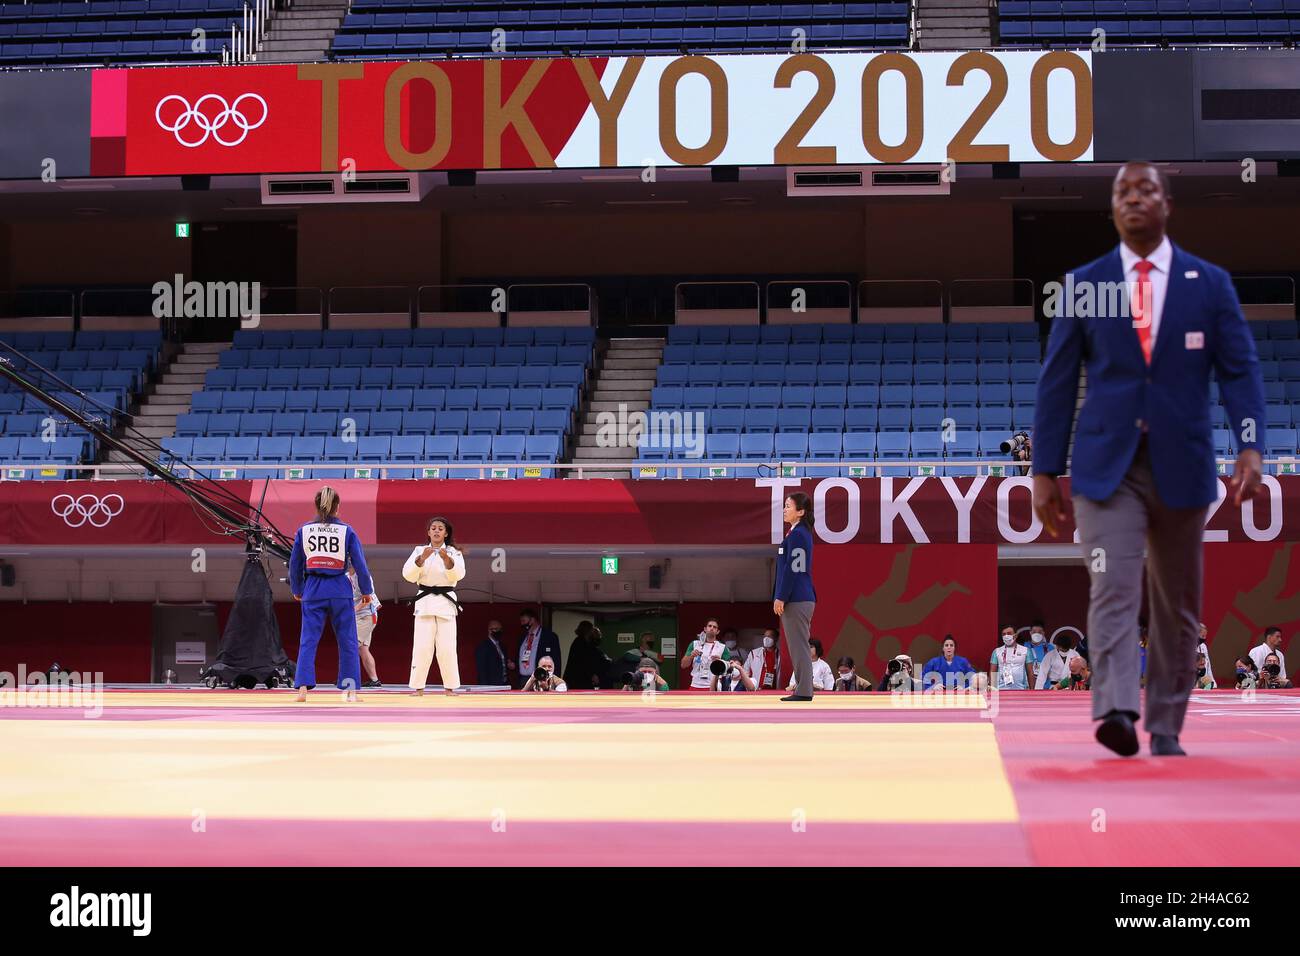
[163,328,595,477]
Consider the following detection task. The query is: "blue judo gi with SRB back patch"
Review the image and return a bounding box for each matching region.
[289,519,374,691]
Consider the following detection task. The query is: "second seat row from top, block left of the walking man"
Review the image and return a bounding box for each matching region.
[663,342,1041,365]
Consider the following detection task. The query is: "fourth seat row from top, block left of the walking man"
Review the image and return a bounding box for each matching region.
[650,382,1037,410]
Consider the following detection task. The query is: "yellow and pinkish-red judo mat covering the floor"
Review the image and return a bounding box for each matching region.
[0,687,1300,866]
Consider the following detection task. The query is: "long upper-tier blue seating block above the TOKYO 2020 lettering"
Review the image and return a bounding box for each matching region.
[333,0,909,60]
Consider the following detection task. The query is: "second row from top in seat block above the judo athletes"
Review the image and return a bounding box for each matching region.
[217,345,592,368]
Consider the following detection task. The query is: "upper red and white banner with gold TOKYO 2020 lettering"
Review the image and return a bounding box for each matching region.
[91,51,1093,176]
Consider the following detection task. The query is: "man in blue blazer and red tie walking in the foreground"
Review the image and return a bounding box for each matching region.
[1034,163,1265,757]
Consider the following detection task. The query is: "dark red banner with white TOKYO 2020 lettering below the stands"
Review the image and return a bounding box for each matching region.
[0,475,1300,546]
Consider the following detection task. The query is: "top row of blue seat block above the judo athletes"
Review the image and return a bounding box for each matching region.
[233,325,595,349]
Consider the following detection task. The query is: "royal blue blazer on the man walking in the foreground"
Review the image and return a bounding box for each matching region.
[1034,246,1265,509]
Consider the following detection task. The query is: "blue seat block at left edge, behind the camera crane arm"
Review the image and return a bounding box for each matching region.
[0,332,163,480]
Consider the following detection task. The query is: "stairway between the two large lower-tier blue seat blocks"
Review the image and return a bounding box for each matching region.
[566,338,666,479]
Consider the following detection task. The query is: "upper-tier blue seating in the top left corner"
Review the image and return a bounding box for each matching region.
[0,0,243,66]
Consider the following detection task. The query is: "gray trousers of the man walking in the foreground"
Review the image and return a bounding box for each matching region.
[1074,438,1206,735]
